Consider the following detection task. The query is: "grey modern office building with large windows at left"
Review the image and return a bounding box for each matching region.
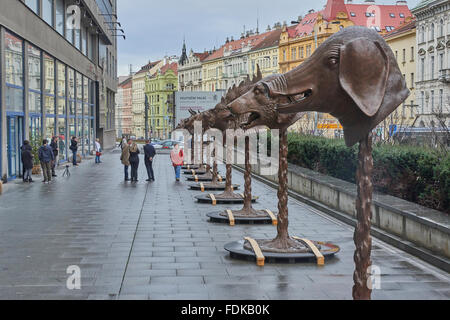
[0,0,117,181]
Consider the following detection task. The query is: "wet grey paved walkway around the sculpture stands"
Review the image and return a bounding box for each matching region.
[0,151,450,300]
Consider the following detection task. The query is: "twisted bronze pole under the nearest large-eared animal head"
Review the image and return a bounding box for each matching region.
[353,133,373,300]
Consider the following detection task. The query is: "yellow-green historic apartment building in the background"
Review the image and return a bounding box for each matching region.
[144,61,178,139]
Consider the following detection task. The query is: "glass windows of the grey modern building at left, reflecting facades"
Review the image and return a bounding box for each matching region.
[0,0,117,180]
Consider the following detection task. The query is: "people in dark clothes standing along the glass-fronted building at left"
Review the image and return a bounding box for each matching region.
[21,136,102,183]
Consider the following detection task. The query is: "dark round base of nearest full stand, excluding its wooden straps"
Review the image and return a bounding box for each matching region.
[224,240,340,263]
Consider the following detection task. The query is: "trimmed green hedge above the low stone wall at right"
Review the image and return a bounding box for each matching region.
[288,133,450,213]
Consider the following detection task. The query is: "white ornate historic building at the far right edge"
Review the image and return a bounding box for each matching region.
[412,0,450,128]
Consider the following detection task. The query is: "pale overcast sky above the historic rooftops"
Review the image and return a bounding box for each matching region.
[117,0,420,75]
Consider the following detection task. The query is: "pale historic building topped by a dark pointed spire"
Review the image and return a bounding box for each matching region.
[178,43,209,91]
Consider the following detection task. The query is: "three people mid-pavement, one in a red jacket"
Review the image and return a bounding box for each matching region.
[120,139,184,182]
